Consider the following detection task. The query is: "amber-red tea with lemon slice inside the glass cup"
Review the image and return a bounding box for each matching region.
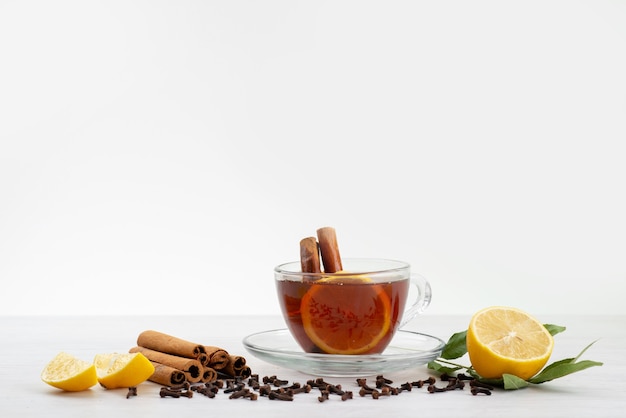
[276,276,410,354]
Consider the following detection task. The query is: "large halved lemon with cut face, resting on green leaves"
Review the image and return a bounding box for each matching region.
[466,306,554,380]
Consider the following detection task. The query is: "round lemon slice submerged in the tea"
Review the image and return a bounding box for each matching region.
[300,276,391,354]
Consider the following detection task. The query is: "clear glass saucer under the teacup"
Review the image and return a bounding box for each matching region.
[243,329,445,377]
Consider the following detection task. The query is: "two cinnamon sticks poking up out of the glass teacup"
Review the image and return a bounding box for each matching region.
[300,226,343,273]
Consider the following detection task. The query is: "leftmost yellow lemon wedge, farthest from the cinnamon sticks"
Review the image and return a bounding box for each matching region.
[41,352,98,392]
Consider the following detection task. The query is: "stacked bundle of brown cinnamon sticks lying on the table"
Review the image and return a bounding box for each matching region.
[129,330,252,386]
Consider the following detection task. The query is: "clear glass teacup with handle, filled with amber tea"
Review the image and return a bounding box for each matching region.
[274,259,432,354]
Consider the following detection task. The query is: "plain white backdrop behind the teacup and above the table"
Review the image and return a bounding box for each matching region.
[0,0,626,314]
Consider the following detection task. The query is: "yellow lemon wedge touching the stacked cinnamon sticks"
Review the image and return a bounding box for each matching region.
[93,353,154,389]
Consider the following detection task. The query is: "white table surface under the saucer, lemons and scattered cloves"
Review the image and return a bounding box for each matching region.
[0,315,626,418]
